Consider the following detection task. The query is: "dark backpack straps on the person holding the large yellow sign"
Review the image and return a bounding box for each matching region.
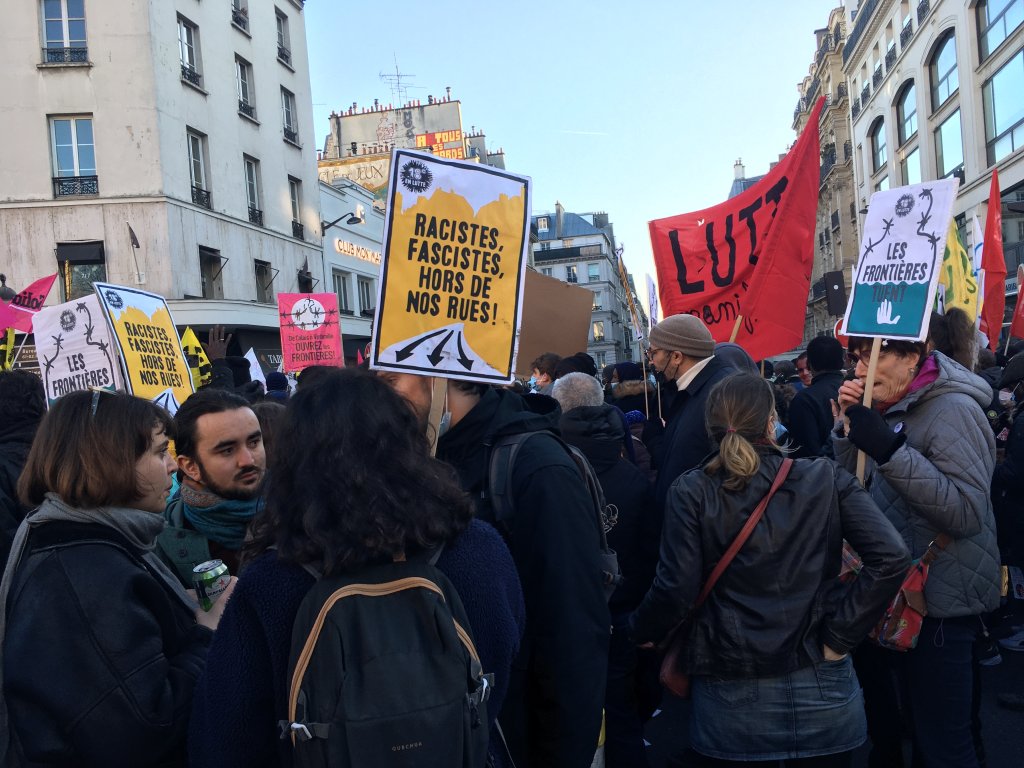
[487,431,623,600]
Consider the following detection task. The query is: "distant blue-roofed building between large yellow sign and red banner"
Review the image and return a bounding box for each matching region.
[530,203,646,369]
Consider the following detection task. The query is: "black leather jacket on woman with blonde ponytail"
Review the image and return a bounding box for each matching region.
[632,451,909,678]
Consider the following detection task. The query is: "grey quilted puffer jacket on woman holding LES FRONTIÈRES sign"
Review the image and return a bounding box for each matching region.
[833,352,999,618]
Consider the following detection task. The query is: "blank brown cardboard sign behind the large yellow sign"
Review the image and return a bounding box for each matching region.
[515,269,594,379]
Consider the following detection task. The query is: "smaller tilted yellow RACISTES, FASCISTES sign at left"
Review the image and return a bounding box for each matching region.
[92,283,196,414]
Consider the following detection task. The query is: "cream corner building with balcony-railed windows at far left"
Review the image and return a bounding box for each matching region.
[0,0,324,358]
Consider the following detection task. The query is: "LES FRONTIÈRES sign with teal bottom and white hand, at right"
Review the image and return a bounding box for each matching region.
[843,178,958,341]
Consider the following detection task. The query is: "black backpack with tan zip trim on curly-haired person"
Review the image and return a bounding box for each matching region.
[280,555,494,768]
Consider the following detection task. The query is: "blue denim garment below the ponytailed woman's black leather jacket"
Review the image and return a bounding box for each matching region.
[690,656,867,761]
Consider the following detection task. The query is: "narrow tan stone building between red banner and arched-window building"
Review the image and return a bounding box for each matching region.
[793,5,859,344]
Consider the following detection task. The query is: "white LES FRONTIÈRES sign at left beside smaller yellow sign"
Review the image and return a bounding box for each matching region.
[32,296,124,404]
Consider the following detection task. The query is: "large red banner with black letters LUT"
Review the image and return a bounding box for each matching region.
[649,98,824,359]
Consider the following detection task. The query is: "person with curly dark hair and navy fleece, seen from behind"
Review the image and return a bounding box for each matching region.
[189,369,524,768]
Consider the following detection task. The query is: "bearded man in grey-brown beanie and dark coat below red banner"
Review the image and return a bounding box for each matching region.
[643,314,734,513]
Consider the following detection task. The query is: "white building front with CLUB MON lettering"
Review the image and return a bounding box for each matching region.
[318,179,384,362]
